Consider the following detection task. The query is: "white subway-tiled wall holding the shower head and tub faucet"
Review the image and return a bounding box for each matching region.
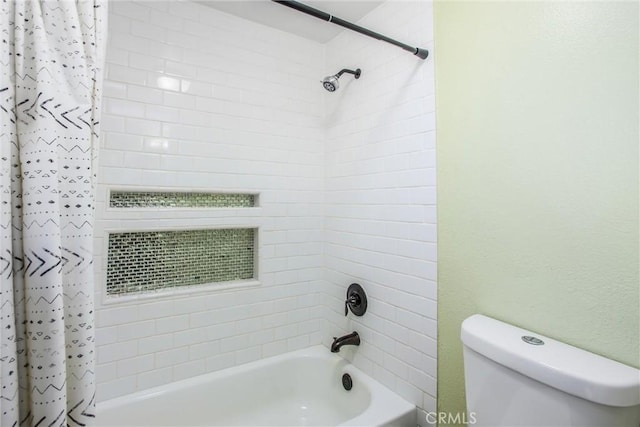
[322,1,437,416]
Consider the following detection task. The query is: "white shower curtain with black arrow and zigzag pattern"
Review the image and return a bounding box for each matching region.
[0,0,107,427]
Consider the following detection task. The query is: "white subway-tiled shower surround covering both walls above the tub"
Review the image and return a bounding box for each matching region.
[96,0,436,416]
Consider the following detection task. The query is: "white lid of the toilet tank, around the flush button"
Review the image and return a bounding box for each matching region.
[461,314,640,407]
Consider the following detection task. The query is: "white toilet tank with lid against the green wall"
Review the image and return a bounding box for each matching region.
[461,314,640,427]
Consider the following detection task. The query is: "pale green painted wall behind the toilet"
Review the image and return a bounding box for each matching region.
[435,1,640,422]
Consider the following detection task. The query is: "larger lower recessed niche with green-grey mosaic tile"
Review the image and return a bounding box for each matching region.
[107,228,256,295]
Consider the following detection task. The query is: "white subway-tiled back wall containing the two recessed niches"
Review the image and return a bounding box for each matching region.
[95,1,324,401]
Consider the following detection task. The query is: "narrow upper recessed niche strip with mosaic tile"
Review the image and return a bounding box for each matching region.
[109,191,256,208]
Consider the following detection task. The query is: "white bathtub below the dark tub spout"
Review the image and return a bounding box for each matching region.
[96,346,416,427]
